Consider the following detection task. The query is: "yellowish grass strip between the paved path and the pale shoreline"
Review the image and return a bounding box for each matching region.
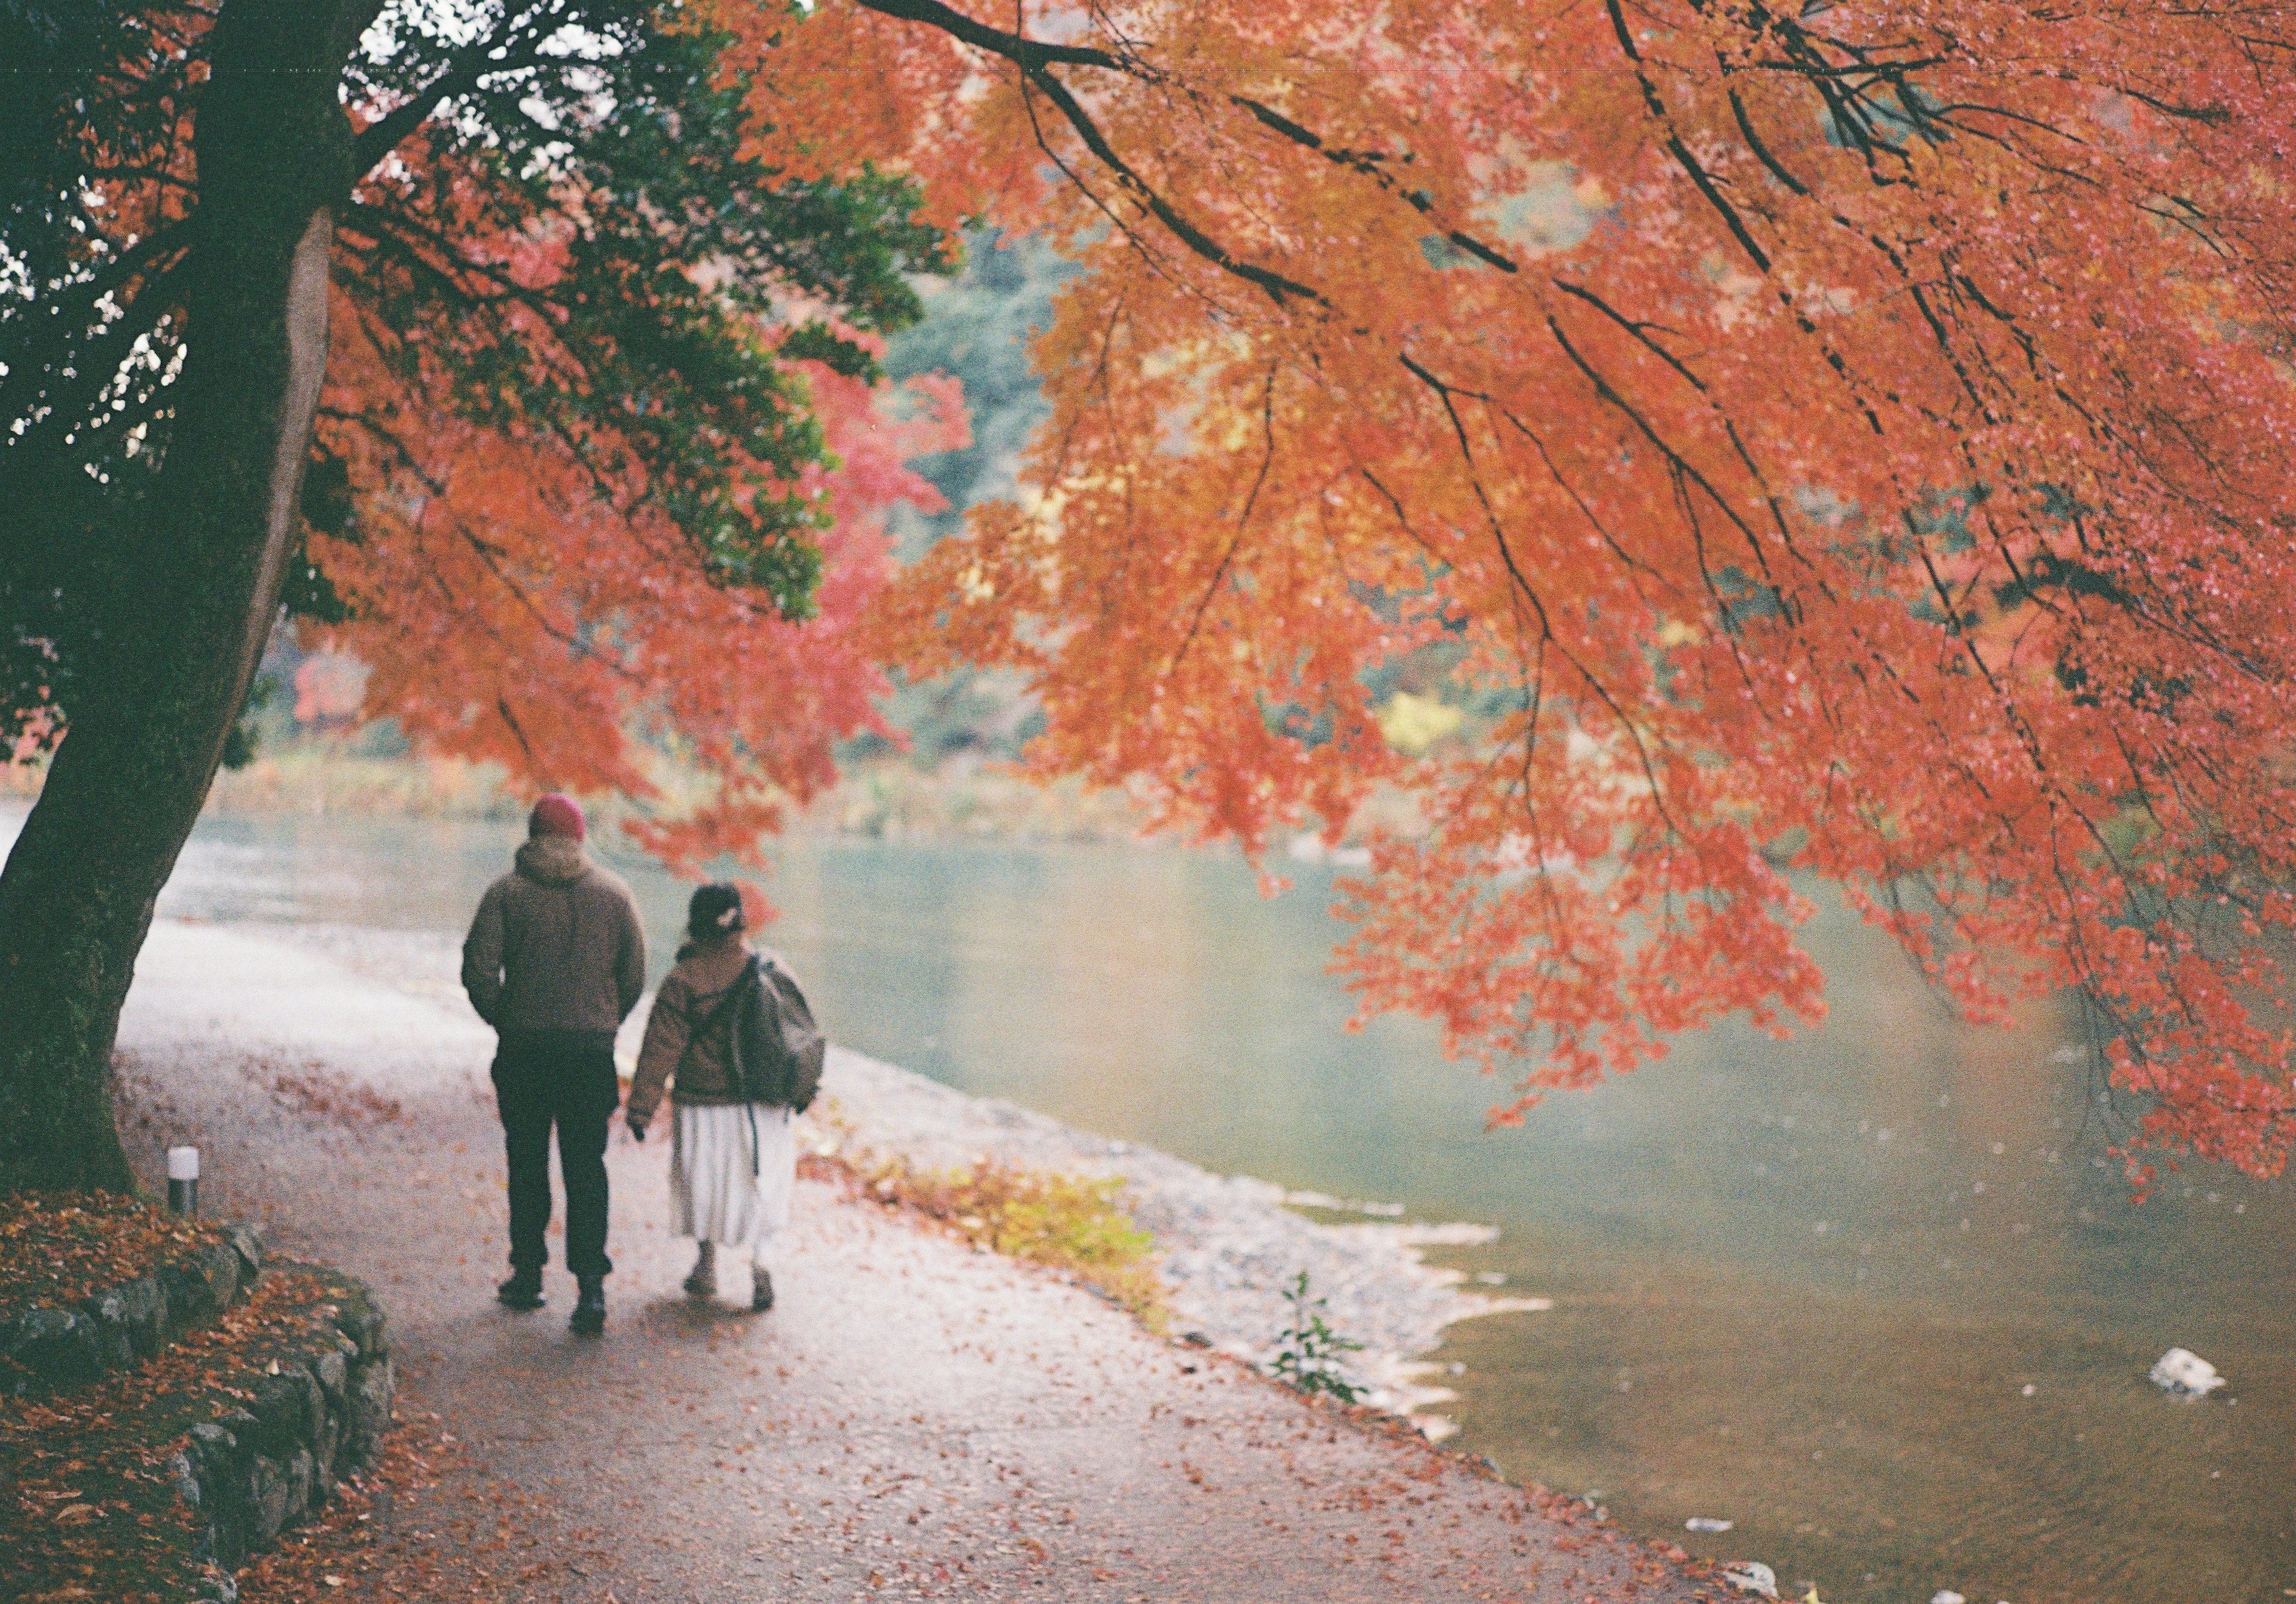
[806,1146,1167,1333]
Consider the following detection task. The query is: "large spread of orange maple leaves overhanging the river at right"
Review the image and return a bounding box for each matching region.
[836,0,2296,1170]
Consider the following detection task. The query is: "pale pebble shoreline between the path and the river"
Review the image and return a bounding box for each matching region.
[237,924,1547,1438]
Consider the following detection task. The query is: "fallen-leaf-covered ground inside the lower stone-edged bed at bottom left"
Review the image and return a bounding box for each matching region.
[0,1268,346,1604]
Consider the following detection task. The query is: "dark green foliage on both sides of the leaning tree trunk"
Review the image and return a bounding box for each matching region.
[0,0,953,740]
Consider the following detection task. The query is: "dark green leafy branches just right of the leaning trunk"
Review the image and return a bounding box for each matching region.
[347,5,951,618]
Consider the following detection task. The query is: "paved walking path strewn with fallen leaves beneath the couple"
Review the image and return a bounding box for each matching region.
[122,924,1697,1604]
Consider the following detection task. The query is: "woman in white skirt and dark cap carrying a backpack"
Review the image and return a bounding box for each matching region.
[622,885,813,1312]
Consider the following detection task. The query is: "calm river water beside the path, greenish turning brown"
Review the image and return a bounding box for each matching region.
[76,821,2296,1604]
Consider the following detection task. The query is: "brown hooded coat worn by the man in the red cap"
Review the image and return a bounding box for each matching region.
[462,837,645,1036]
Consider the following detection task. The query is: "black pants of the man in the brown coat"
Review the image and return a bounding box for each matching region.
[494,1029,620,1277]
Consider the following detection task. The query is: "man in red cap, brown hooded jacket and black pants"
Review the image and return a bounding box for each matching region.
[462,793,645,1335]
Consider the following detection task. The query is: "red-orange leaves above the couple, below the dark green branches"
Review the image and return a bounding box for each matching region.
[319,294,964,867]
